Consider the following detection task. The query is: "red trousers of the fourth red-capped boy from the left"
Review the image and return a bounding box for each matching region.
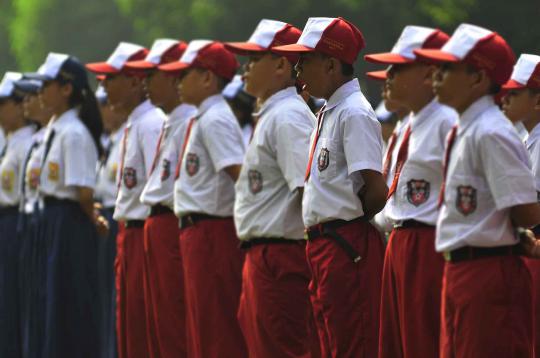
[238,240,319,358]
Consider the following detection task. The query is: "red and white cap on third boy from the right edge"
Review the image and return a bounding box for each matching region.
[364,26,450,65]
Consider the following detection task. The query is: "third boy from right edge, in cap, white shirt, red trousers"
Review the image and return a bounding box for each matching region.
[365,26,457,358]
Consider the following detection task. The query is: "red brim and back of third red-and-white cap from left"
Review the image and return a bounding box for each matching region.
[158,42,240,80]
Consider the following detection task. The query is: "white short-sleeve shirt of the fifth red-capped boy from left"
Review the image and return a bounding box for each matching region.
[302,79,383,227]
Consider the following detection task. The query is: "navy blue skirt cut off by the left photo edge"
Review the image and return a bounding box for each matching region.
[0,207,21,358]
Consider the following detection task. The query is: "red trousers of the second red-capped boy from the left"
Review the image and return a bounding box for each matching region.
[144,213,186,358]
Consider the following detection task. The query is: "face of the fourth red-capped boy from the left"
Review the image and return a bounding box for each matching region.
[243,52,280,98]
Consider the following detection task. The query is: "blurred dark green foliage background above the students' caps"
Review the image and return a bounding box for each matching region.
[0,0,540,97]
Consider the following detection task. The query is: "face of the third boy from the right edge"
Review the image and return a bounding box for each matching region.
[386,62,431,107]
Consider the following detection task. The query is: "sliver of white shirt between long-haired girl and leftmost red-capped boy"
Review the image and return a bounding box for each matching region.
[95,123,126,208]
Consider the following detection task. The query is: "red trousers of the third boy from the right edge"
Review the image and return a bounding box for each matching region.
[379,227,444,358]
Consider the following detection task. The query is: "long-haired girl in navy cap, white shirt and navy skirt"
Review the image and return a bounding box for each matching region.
[27,53,104,358]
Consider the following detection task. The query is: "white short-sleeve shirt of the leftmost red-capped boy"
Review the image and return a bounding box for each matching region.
[113,100,167,221]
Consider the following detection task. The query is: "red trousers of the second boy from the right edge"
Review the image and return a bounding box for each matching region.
[440,256,533,358]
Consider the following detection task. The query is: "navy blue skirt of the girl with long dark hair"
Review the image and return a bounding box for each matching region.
[39,198,100,358]
